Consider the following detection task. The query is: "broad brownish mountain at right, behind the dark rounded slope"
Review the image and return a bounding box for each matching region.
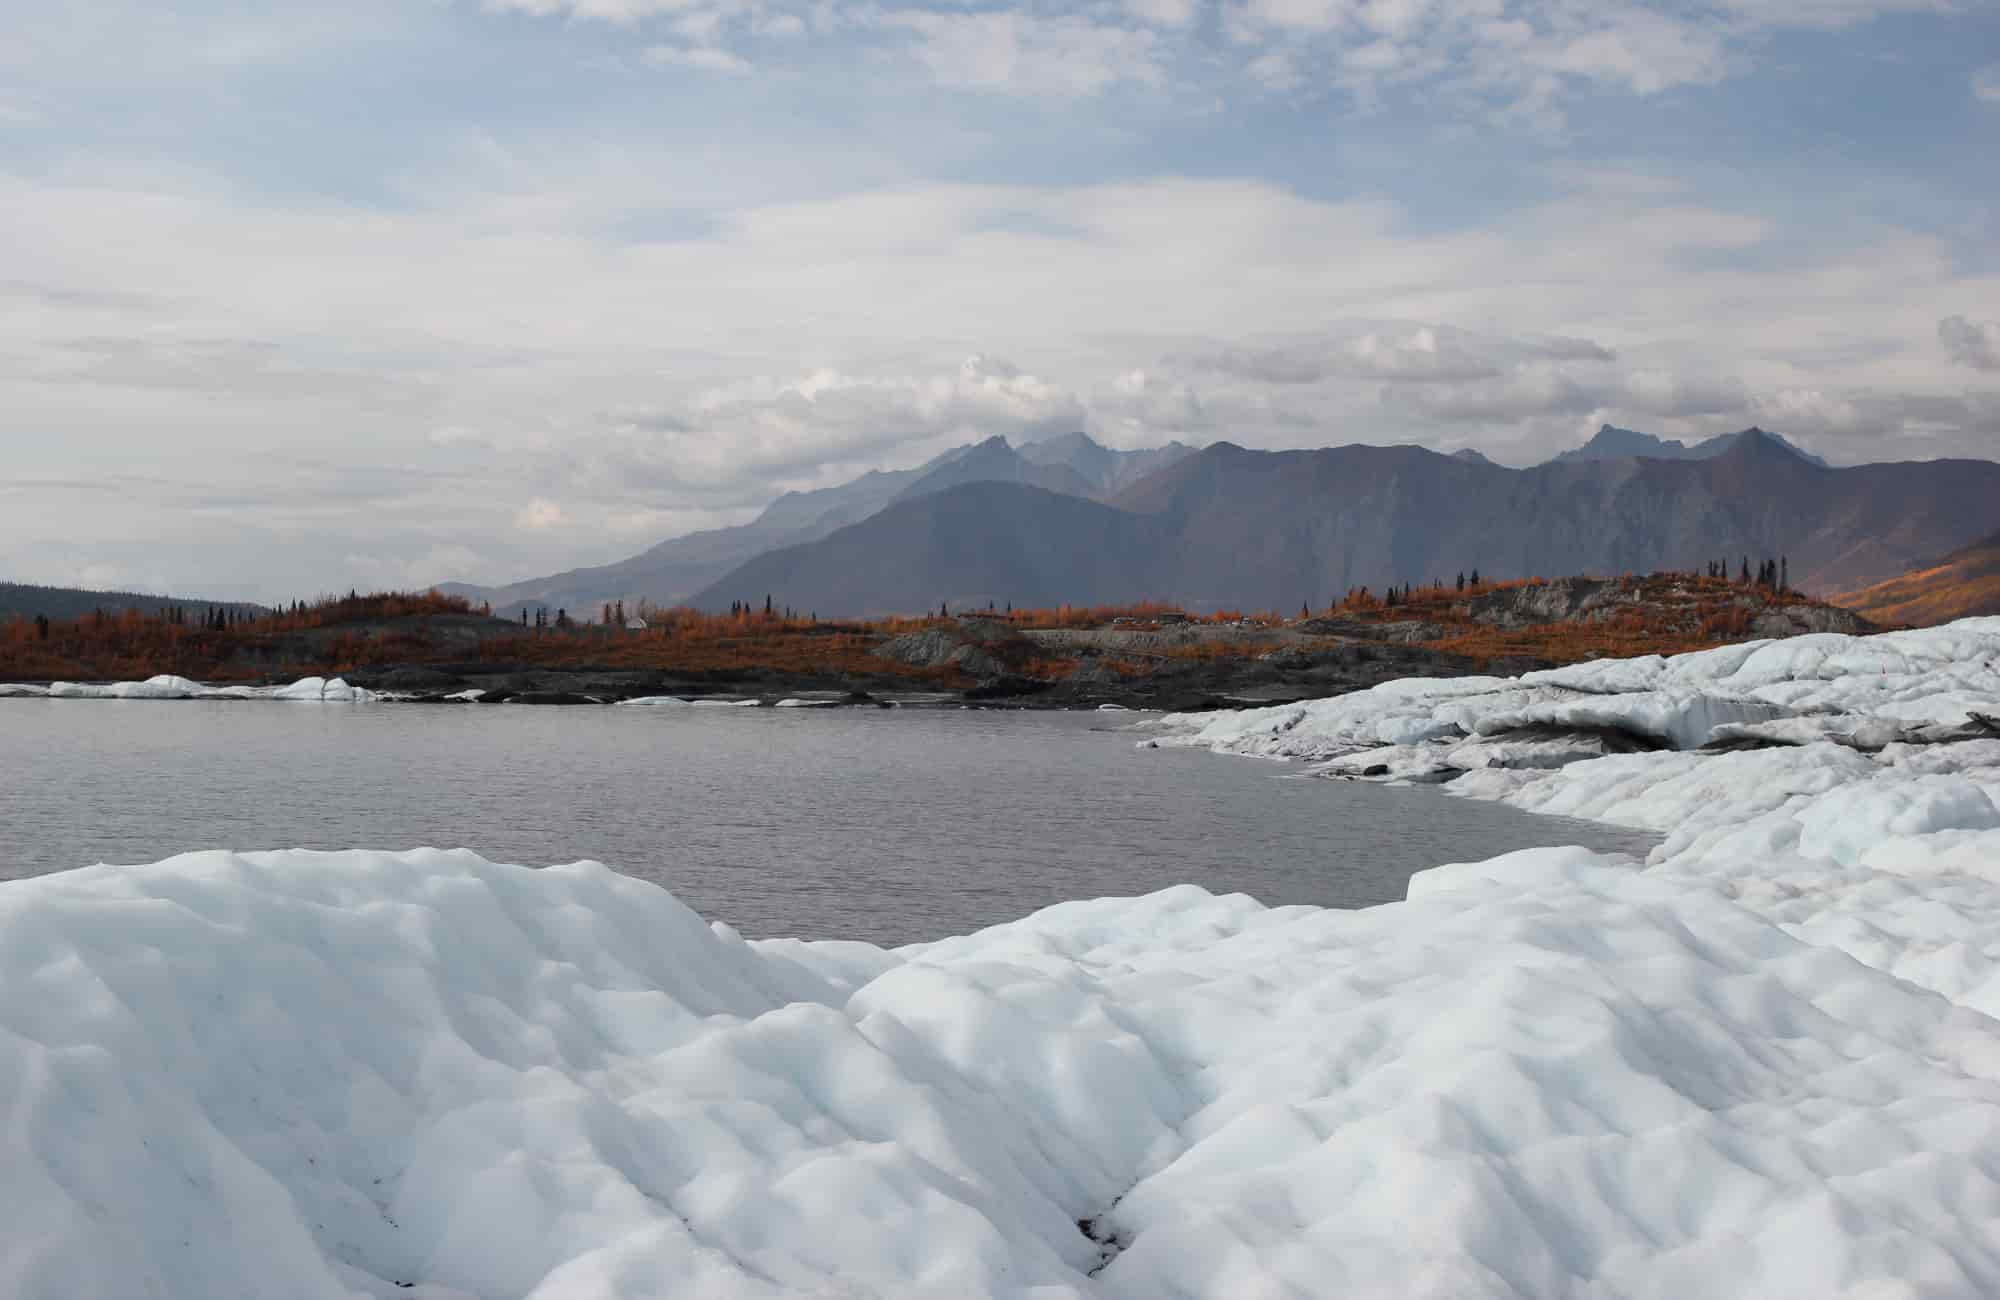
[1112,434,2000,608]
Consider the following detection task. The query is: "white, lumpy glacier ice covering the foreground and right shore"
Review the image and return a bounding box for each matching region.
[0,620,2000,1300]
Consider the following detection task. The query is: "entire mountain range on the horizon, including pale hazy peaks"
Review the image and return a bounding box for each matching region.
[446,426,2000,616]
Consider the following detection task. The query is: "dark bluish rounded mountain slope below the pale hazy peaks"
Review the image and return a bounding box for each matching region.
[692,482,1166,614]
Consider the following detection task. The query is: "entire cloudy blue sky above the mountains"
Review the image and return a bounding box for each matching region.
[0,0,2000,600]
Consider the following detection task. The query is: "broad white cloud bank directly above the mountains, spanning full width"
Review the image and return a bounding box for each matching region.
[0,160,2000,598]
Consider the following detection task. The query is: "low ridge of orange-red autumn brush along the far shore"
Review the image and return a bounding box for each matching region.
[0,574,1856,686]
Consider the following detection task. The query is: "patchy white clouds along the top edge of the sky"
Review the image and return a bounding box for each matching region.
[458,0,1968,122]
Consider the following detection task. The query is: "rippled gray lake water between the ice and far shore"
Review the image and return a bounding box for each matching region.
[0,700,1654,944]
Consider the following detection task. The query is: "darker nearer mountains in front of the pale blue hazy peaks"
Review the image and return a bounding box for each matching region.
[698,434,2000,614]
